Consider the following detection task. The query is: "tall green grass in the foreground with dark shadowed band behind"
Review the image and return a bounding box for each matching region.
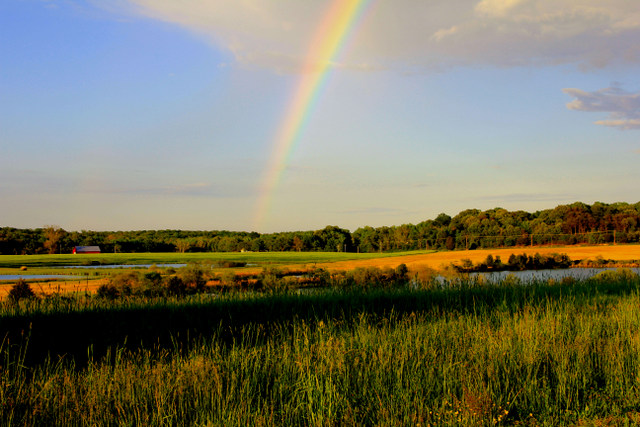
[0,270,640,425]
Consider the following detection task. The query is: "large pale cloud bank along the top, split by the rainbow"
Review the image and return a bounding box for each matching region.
[100,0,640,71]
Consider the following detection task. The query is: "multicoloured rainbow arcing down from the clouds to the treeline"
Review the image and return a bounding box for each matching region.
[254,0,373,230]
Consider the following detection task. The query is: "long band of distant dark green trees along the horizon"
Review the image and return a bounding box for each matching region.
[0,202,640,255]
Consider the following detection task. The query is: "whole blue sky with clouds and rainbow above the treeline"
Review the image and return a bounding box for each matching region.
[0,0,640,232]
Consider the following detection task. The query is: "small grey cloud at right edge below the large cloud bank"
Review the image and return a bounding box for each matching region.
[563,87,640,130]
